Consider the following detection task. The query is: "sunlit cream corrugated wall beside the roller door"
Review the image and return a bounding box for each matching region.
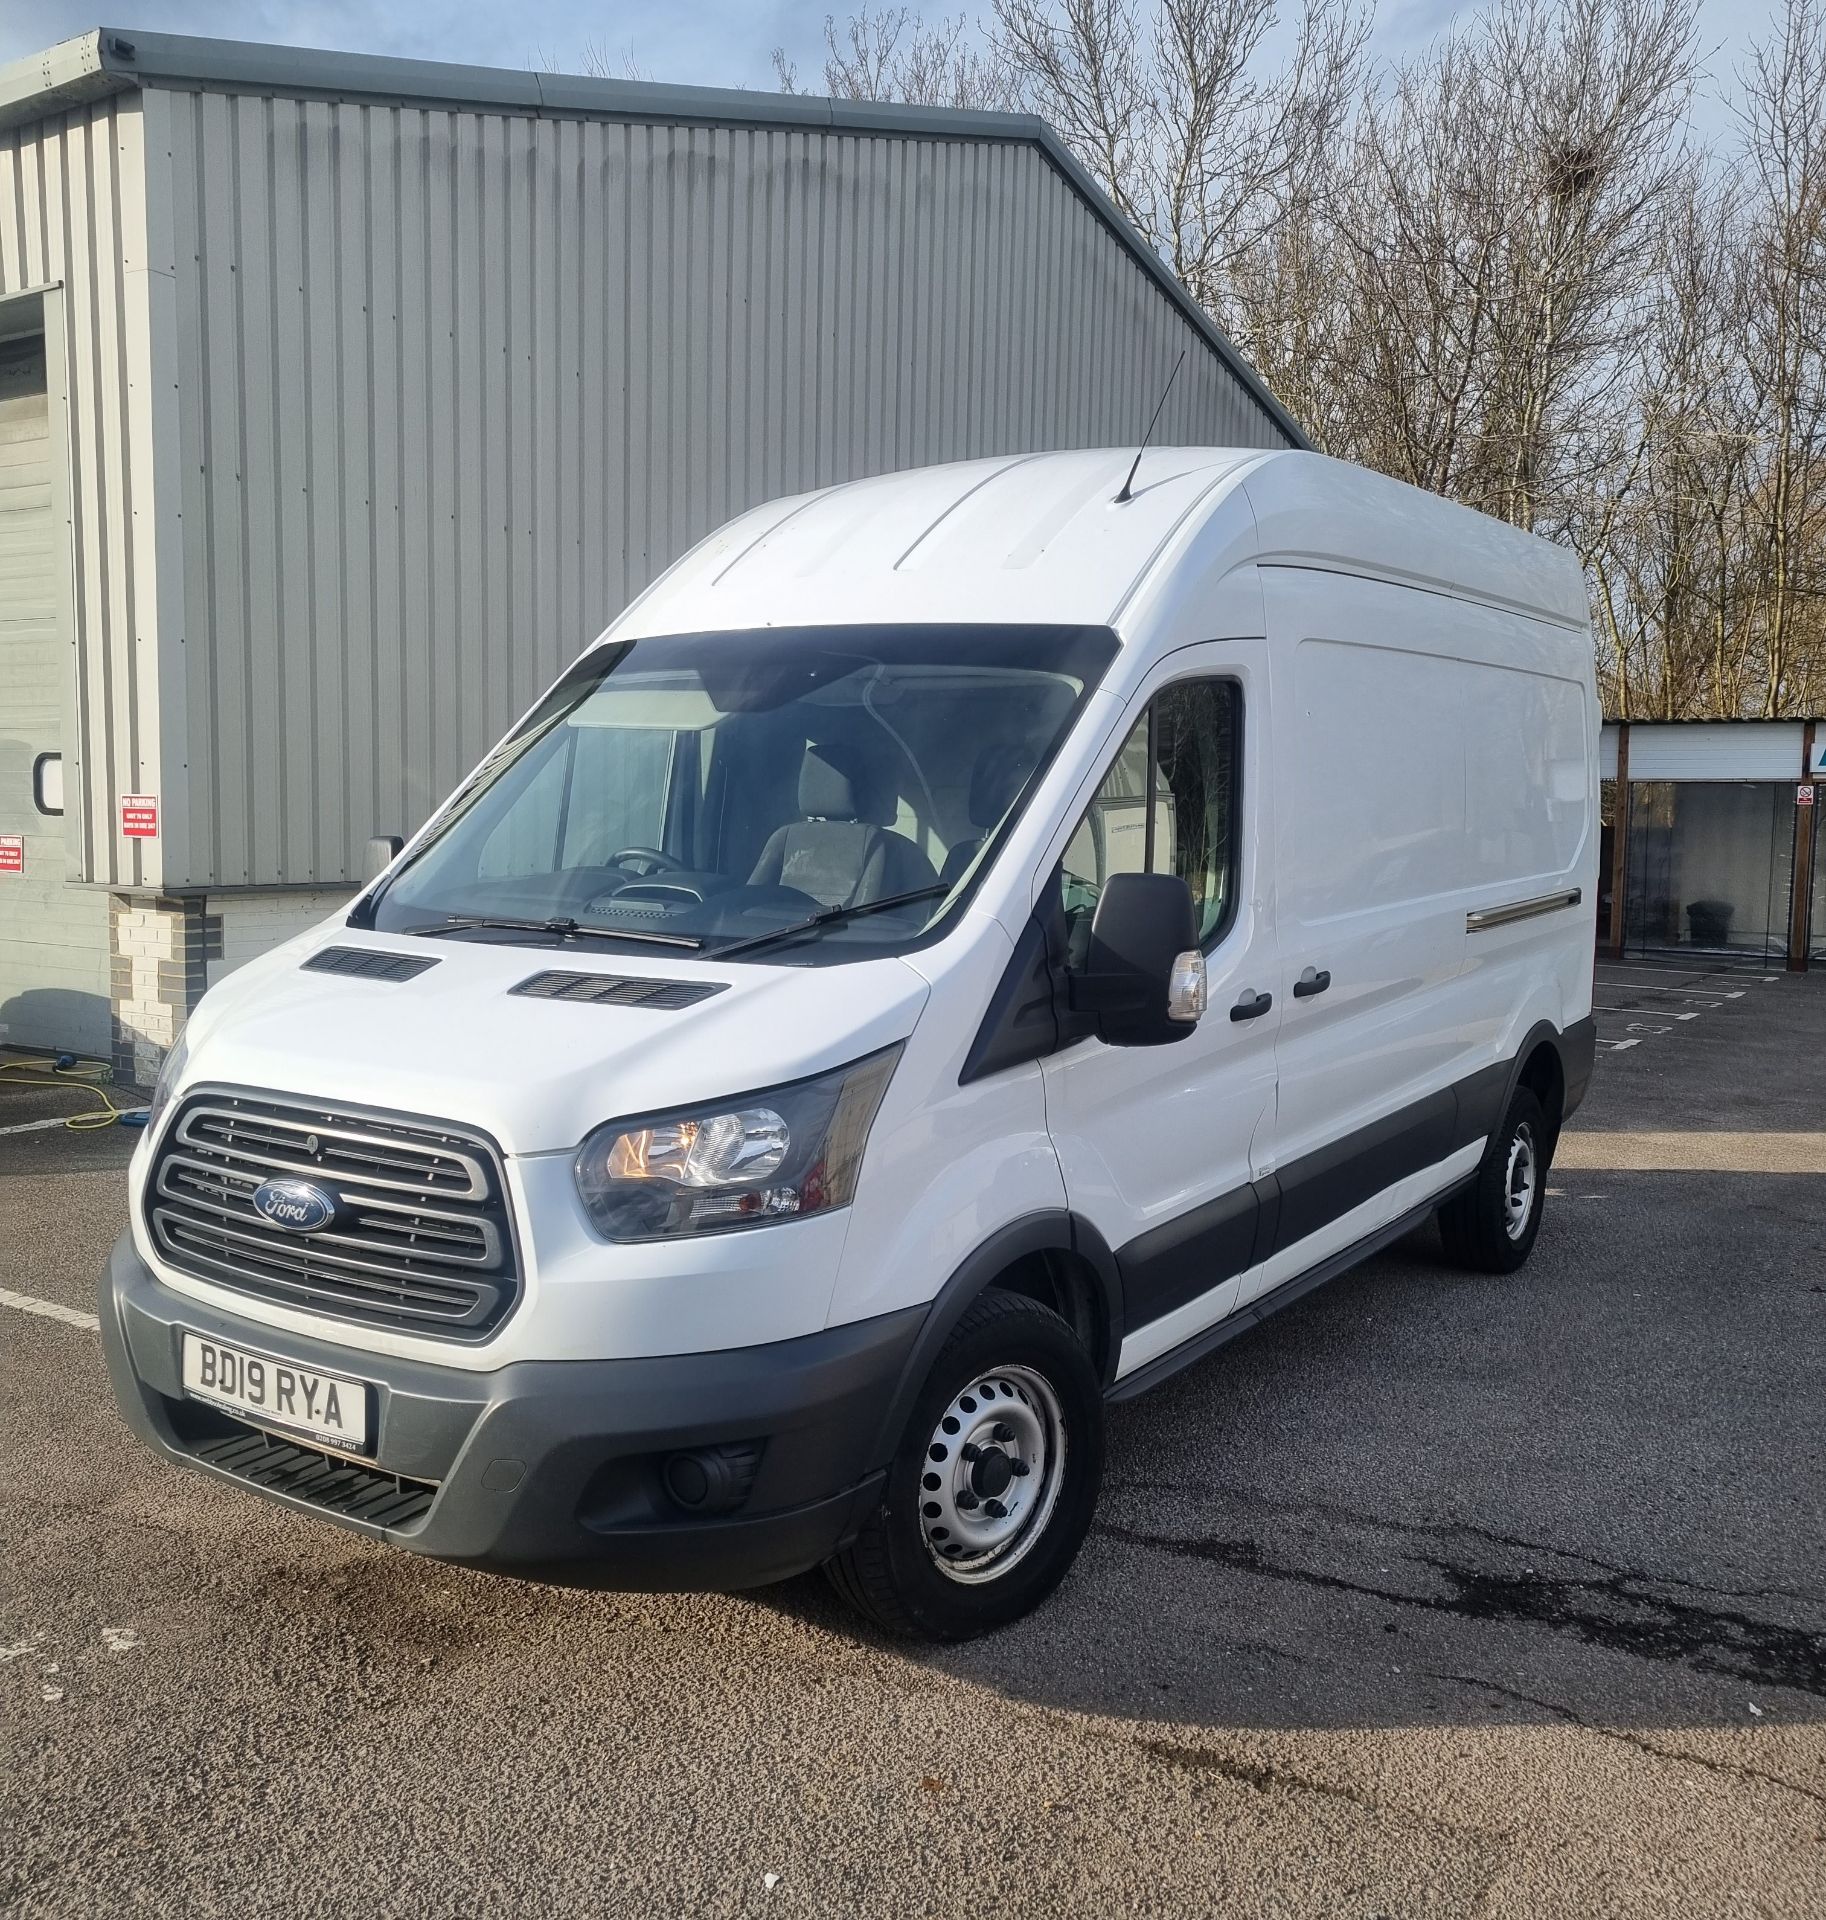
[0,94,173,885]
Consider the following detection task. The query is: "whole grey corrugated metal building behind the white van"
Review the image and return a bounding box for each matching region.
[0,29,1300,1073]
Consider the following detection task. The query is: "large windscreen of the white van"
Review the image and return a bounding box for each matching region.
[357,626,1116,964]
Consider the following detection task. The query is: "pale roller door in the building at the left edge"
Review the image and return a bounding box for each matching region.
[0,334,109,1060]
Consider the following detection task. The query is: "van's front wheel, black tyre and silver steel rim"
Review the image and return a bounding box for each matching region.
[826,1290,1104,1640]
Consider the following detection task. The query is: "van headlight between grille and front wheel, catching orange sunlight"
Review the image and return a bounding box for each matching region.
[576,1046,901,1240]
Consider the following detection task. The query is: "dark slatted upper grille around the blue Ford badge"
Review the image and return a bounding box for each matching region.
[146,1089,520,1340]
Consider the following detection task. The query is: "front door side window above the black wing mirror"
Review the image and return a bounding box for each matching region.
[1060,680,1242,966]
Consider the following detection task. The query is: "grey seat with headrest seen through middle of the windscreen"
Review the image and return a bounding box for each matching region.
[749,741,939,906]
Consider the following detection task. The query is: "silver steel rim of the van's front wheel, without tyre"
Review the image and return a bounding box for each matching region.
[920,1367,1066,1586]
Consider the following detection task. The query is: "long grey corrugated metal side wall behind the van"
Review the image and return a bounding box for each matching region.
[144,92,1283,887]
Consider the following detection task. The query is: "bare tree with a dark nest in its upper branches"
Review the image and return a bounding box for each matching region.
[1331,0,1694,534]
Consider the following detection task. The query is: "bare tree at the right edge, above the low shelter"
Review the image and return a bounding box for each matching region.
[1588,0,1826,718]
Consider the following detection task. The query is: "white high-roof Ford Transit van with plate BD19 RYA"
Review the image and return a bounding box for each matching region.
[102,449,1598,1638]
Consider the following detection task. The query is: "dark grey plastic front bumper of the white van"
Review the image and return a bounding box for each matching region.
[100,1235,925,1590]
